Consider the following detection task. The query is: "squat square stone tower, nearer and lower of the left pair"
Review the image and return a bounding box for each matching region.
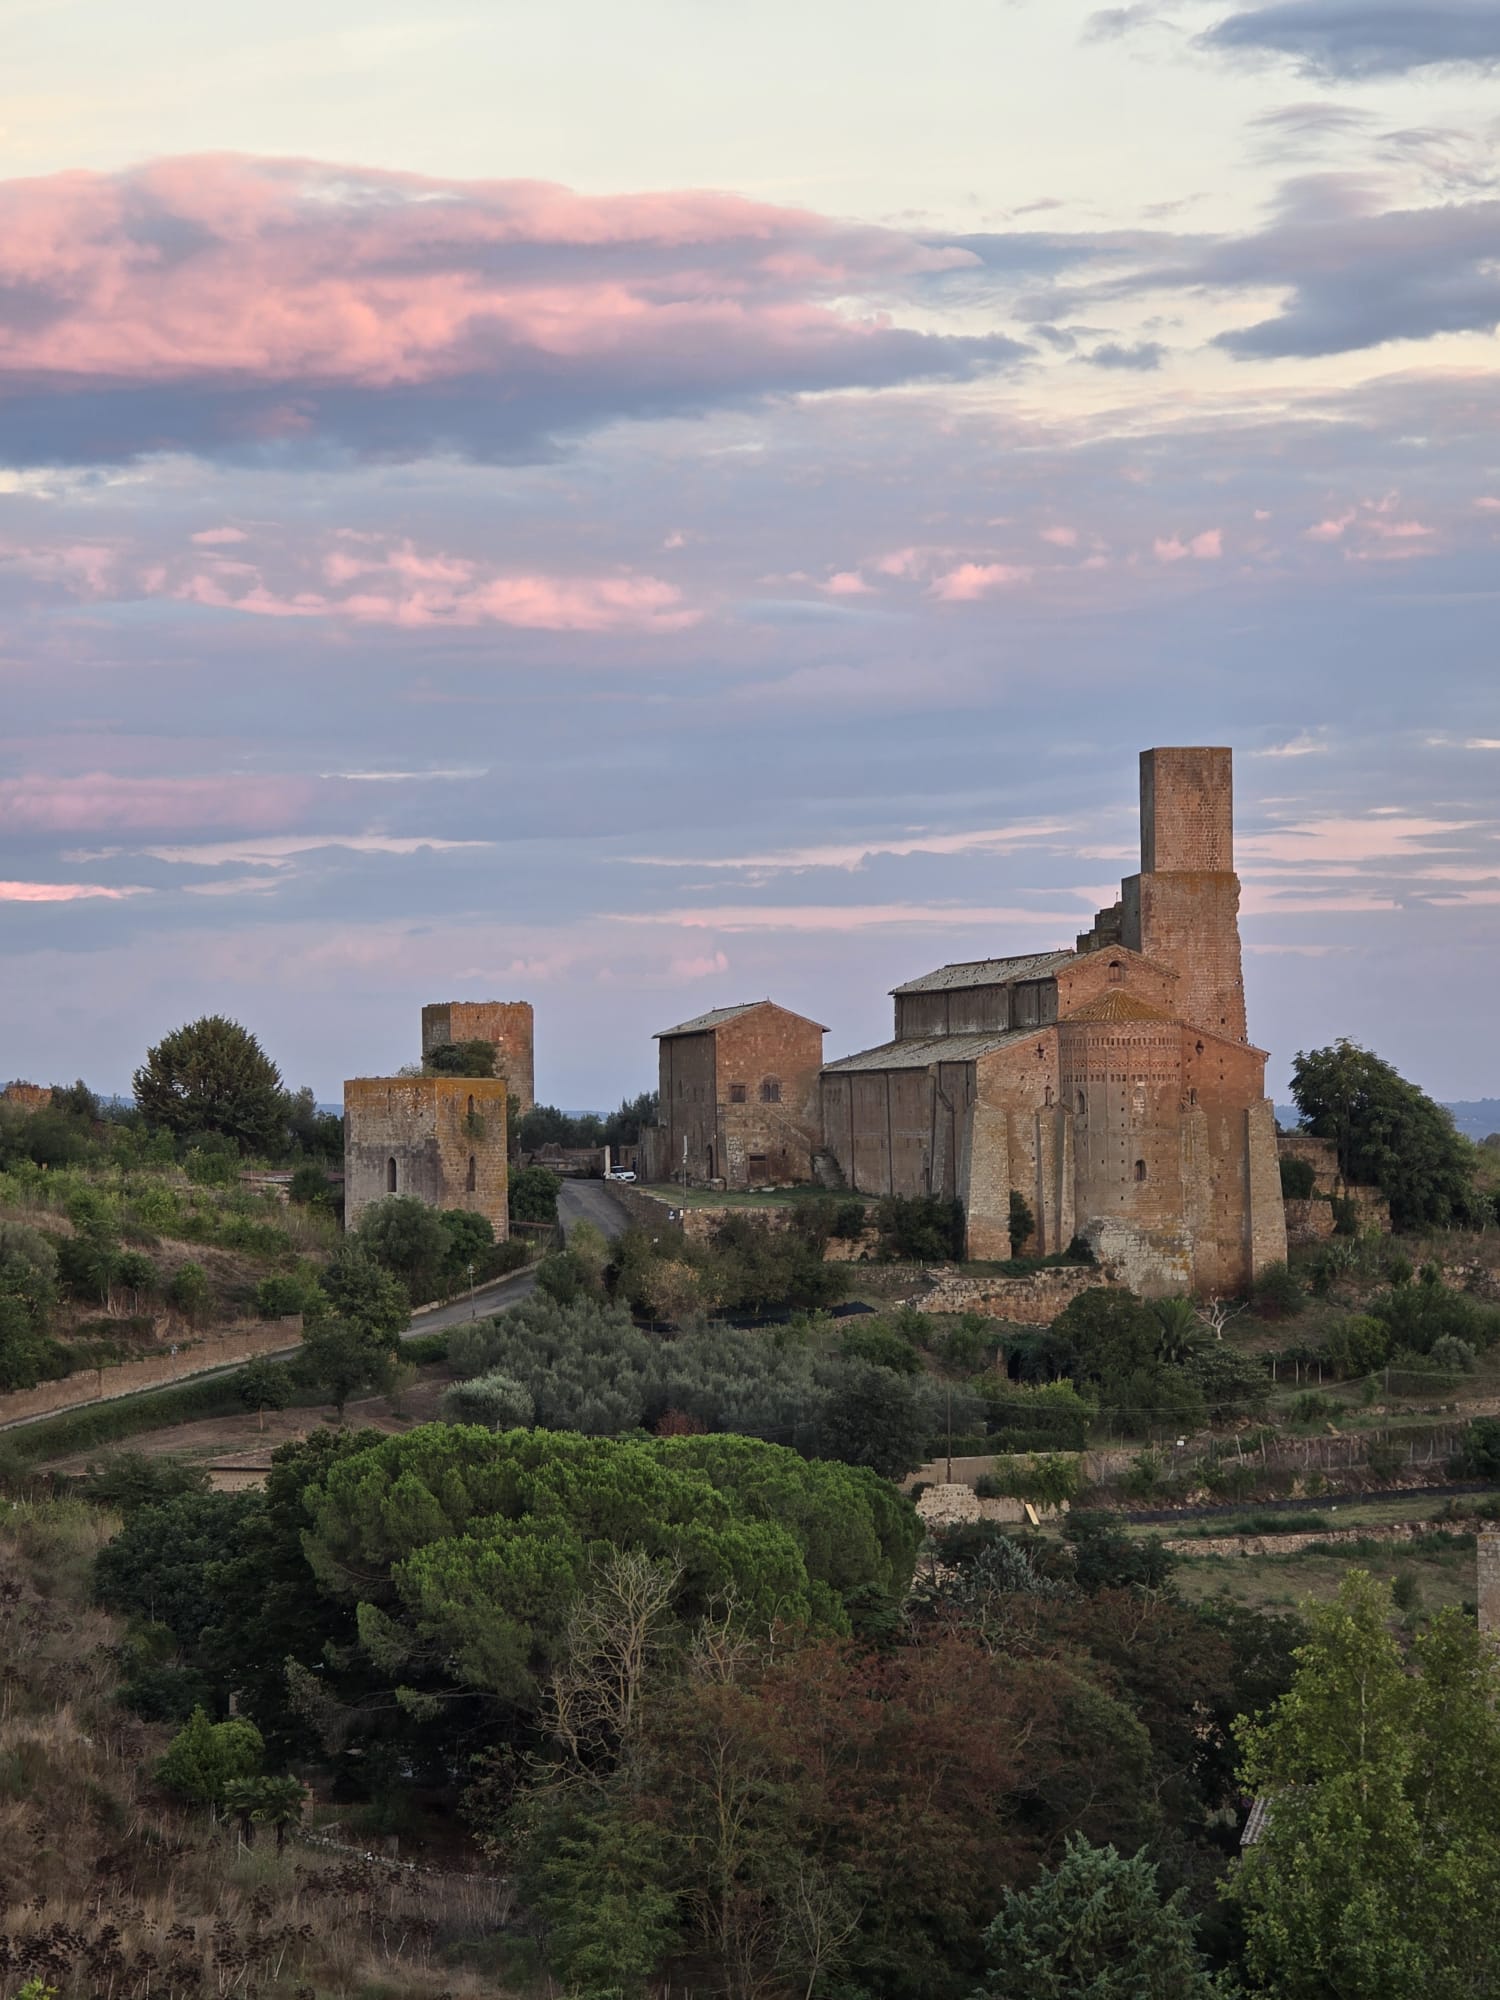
[344,1080,510,1242]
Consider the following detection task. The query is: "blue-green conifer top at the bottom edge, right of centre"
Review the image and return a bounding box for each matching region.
[976,1834,1222,2000]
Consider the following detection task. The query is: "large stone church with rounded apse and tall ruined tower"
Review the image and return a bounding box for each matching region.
[822,748,1286,1294]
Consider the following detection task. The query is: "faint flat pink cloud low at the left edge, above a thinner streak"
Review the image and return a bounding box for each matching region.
[0,772,316,834]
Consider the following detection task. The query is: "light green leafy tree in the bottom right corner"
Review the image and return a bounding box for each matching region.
[1226,1570,1500,2000]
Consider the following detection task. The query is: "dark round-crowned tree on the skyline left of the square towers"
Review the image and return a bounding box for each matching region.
[134,1014,286,1152]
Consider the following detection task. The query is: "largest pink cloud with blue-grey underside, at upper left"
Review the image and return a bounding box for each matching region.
[0,156,1026,466]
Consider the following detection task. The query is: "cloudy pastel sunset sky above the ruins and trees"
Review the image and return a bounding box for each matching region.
[0,0,1500,1106]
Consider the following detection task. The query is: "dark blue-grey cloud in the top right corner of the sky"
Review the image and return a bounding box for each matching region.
[1198,0,1500,82]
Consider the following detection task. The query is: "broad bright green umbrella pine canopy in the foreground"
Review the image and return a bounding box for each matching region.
[306,1424,916,1702]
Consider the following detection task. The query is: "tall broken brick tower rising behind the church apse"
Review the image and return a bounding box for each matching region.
[1120,748,1250,1042]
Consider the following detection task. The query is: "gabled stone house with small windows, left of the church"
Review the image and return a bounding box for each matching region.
[640,1000,828,1188]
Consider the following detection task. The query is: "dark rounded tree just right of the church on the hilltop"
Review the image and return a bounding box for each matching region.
[1292,1040,1492,1230]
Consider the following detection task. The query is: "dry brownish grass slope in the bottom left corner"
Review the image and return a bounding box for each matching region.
[0,1500,524,2000]
